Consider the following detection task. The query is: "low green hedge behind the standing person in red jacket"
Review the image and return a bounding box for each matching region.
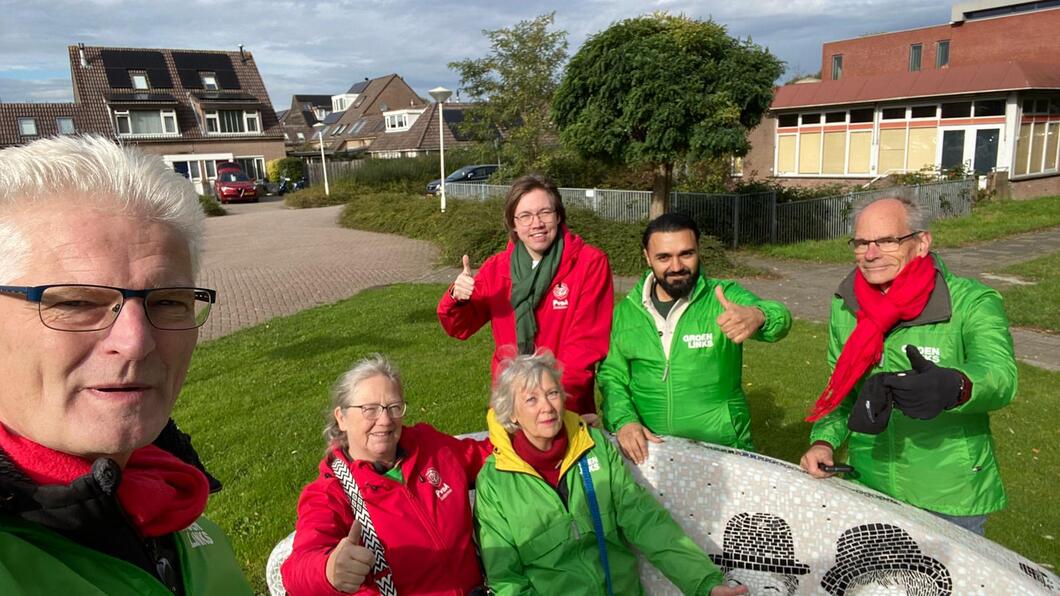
[333,192,752,277]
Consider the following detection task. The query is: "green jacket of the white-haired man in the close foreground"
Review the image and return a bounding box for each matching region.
[0,515,251,596]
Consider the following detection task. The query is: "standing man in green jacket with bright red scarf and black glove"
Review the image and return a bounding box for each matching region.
[801,197,1017,534]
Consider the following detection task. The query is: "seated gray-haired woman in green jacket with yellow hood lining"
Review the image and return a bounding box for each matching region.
[475,352,747,596]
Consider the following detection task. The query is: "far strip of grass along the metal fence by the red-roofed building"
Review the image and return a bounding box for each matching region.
[750,196,1060,263]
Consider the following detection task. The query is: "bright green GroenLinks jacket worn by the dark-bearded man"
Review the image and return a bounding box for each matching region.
[597,271,792,451]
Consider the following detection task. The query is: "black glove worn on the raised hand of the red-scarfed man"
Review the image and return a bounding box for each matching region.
[884,346,965,420]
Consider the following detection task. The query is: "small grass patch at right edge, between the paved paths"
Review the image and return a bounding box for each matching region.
[995,252,1060,333]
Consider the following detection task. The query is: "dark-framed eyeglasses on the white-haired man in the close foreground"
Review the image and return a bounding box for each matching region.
[0,284,217,331]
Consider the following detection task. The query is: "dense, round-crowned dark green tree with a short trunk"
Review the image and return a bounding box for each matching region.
[552,14,783,217]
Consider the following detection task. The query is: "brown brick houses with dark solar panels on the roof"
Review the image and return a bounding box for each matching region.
[0,45,284,192]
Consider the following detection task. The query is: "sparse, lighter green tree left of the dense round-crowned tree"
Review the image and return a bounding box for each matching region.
[449,13,567,172]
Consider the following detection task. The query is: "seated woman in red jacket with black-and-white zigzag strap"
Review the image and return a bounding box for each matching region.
[281,354,492,596]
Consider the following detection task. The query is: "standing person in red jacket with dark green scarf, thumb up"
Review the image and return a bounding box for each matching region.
[438,175,615,414]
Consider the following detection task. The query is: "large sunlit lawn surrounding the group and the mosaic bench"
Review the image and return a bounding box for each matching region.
[174,285,1060,593]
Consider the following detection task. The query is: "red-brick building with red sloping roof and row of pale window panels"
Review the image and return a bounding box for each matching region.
[742,1,1060,196]
